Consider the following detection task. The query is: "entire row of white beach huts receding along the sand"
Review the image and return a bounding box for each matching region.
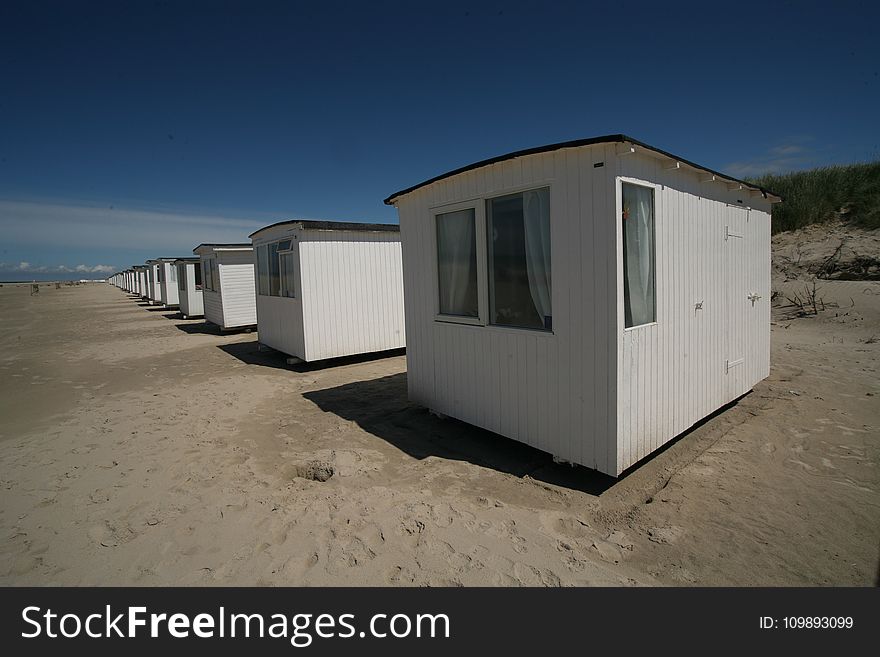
[110,135,781,476]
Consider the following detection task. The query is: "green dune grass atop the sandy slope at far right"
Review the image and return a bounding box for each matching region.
[750,161,880,233]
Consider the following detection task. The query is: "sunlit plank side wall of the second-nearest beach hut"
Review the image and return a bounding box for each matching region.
[299,229,406,361]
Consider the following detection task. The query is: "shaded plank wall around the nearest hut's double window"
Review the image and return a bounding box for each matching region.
[398,144,618,474]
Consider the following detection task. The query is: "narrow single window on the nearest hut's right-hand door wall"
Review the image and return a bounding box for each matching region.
[621,183,657,328]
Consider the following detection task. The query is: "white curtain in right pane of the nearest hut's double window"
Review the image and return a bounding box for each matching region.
[523,187,553,328]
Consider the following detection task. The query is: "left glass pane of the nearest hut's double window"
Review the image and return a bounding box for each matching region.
[437,208,480,317]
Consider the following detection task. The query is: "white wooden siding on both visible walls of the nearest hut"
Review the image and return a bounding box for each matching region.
[397,144,770,475]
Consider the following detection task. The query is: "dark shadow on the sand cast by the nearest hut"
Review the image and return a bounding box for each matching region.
[300,372,616,495]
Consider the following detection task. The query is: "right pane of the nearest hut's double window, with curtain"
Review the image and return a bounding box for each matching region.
[486,187,553,330]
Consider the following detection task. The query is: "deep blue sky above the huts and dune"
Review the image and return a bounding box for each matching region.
[0,0,880,279]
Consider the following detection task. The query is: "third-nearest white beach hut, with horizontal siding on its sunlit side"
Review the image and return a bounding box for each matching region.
[193,244,257,330]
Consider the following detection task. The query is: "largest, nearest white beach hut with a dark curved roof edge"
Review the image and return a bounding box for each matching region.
[385,135,781,476]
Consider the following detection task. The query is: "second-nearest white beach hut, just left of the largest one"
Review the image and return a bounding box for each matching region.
[250,220,406,361]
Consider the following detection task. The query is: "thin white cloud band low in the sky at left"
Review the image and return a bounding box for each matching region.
[0,200,274,255]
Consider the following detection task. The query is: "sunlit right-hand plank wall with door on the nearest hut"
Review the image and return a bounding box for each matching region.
[616,153,770,472]
